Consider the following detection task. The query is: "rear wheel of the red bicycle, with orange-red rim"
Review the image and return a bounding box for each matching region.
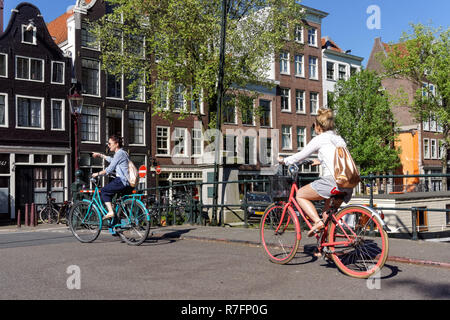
[328,207,389,279]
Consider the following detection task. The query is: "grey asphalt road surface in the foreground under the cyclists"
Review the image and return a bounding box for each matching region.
[0,229,450,301]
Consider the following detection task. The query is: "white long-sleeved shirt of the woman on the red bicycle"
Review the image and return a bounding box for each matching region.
[284,131,347,177]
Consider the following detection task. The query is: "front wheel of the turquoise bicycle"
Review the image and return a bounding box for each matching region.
[69,201,102,243]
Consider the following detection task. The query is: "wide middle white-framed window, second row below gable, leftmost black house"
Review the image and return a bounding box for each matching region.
[17,97,44,129]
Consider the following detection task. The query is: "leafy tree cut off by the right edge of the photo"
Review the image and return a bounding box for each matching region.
[382,24,450,190]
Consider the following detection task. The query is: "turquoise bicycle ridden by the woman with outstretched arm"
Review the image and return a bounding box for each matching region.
[69,178,150,246]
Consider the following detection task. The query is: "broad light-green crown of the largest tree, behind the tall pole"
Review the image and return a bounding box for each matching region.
[94,0,304,125]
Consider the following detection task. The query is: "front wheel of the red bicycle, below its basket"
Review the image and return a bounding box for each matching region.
[260,203,300,264]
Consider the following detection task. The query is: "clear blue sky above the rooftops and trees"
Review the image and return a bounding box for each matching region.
[4,0,450,66]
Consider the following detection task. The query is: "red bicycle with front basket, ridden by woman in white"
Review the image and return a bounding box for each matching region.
[260,161,389,278]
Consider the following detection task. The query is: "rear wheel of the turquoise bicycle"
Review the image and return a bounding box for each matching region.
[117,199,150,246]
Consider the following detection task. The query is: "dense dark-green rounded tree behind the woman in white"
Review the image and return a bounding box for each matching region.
[330,69,400,175]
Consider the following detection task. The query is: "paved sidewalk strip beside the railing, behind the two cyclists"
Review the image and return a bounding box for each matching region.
[0,224,450,269]
